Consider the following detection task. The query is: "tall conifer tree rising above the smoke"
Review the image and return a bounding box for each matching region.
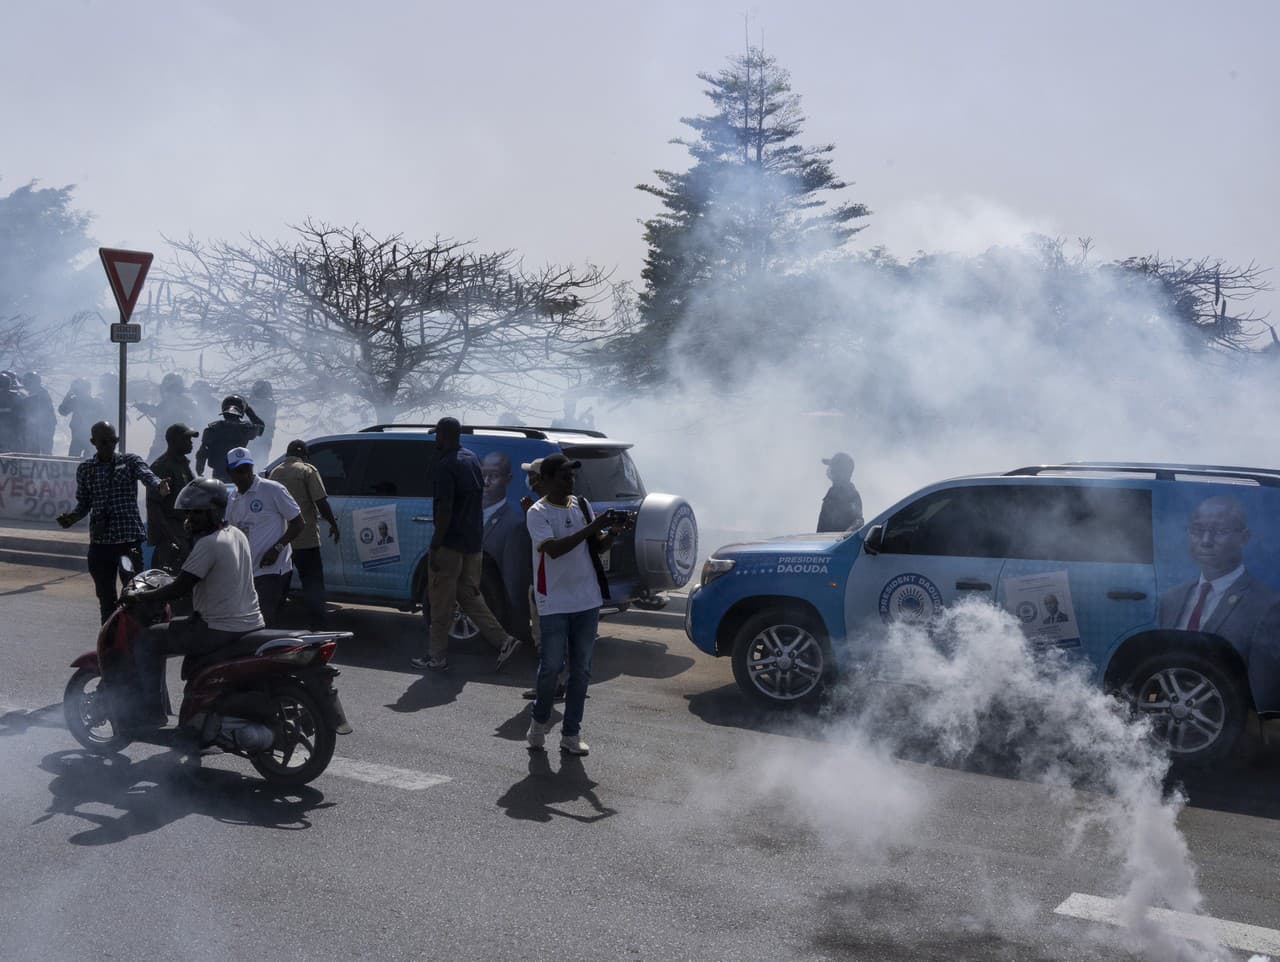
[622,47,869,384]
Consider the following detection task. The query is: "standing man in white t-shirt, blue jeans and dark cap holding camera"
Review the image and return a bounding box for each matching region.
[526,453,626,755]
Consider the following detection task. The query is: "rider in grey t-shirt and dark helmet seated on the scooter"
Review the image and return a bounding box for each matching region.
[127,477,264,725]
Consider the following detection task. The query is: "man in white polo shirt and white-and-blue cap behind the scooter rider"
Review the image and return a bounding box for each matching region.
[227,448,305,628]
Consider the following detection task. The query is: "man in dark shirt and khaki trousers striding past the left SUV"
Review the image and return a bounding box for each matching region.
[411,417,520,672]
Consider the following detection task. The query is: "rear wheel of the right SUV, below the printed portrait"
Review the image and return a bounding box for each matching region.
[1124,651,1248,765]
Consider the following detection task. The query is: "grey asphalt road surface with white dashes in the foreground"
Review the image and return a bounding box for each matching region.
[0,564,1280,961]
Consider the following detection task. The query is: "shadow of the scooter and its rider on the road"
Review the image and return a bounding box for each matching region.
[36,751,334,846]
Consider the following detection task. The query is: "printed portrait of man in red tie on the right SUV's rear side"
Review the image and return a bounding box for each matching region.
[1160,495,1280,651]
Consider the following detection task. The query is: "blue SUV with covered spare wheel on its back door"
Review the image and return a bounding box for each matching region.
[273,425,698,638]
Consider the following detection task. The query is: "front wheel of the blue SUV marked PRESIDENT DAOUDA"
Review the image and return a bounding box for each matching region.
[733,609,832,707]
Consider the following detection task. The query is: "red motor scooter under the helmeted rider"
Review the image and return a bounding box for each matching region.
[63,559,352,785]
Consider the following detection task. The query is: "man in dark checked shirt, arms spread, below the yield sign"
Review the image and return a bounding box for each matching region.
[58,421,169,624]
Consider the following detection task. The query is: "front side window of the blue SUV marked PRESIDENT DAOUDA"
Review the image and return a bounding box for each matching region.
[881,485,1015,558]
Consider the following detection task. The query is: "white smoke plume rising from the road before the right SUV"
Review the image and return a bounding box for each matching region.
[695,601,1249,962]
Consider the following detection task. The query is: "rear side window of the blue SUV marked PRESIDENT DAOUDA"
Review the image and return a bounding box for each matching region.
[1009,485,1155,564]
